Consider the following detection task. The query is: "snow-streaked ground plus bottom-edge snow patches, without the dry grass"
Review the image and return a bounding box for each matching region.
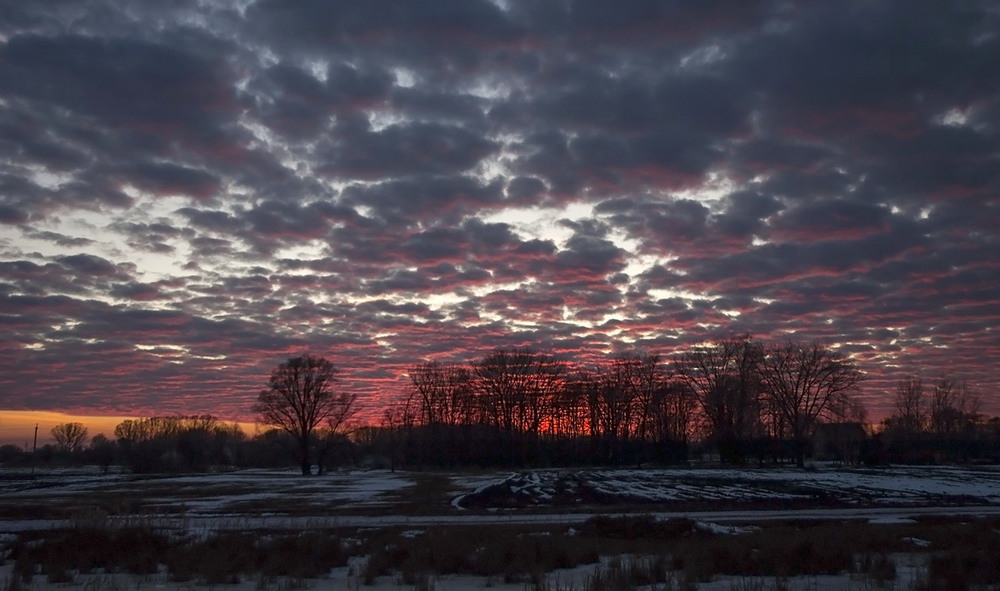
[0,466,1000,591]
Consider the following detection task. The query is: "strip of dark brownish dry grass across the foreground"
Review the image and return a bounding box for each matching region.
[0,512,1000,591]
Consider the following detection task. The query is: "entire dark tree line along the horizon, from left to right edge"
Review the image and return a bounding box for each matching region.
[0,335,1000,474]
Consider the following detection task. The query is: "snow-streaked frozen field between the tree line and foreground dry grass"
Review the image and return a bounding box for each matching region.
[0,466,1000,520]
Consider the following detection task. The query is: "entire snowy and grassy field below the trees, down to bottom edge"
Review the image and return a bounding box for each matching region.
[0,466,1000,591]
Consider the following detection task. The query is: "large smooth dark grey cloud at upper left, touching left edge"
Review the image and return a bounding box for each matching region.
[0,35,233,145]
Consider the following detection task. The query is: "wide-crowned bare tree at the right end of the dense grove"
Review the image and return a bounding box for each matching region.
[758,342,864,466]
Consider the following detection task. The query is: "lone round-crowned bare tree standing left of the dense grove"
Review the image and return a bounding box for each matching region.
[253,355,344,475]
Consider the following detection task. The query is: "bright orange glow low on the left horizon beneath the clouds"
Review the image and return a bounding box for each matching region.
[0,410,261,450]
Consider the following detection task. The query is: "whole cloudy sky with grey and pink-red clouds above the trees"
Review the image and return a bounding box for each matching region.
[0,0,1000,426]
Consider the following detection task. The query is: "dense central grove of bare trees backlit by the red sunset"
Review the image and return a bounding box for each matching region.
[382,335,864,465]
